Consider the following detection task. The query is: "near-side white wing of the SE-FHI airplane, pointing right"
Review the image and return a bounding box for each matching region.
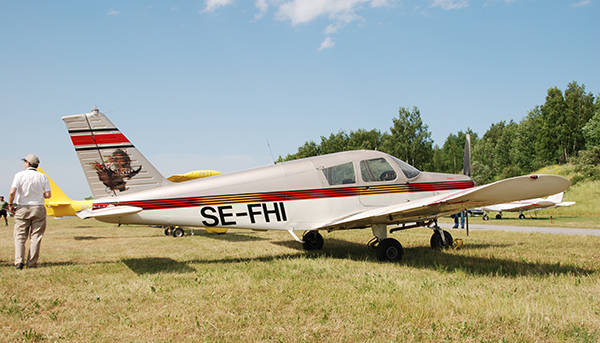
[317,175,571,230]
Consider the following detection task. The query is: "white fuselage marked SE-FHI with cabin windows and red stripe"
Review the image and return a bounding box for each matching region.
[94,151,474,230]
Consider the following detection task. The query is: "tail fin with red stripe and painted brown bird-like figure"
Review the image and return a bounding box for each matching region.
[62,108,168,199]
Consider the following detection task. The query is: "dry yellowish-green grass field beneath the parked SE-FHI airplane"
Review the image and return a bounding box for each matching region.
[0,218,600,342]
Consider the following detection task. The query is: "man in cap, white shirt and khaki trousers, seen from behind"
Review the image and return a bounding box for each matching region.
[8,154,52,269]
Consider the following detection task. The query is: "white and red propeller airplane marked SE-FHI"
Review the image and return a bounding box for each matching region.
[62,108,571,261]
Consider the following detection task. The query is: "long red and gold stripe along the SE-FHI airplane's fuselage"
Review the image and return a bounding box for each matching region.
[93,181,474,210]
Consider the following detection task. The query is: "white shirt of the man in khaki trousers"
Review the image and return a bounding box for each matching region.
[10,168,50,205]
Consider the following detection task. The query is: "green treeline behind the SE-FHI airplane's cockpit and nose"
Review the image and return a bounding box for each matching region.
[278,81,600,184]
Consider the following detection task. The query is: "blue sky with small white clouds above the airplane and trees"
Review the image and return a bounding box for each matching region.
[0,0,600,200]
